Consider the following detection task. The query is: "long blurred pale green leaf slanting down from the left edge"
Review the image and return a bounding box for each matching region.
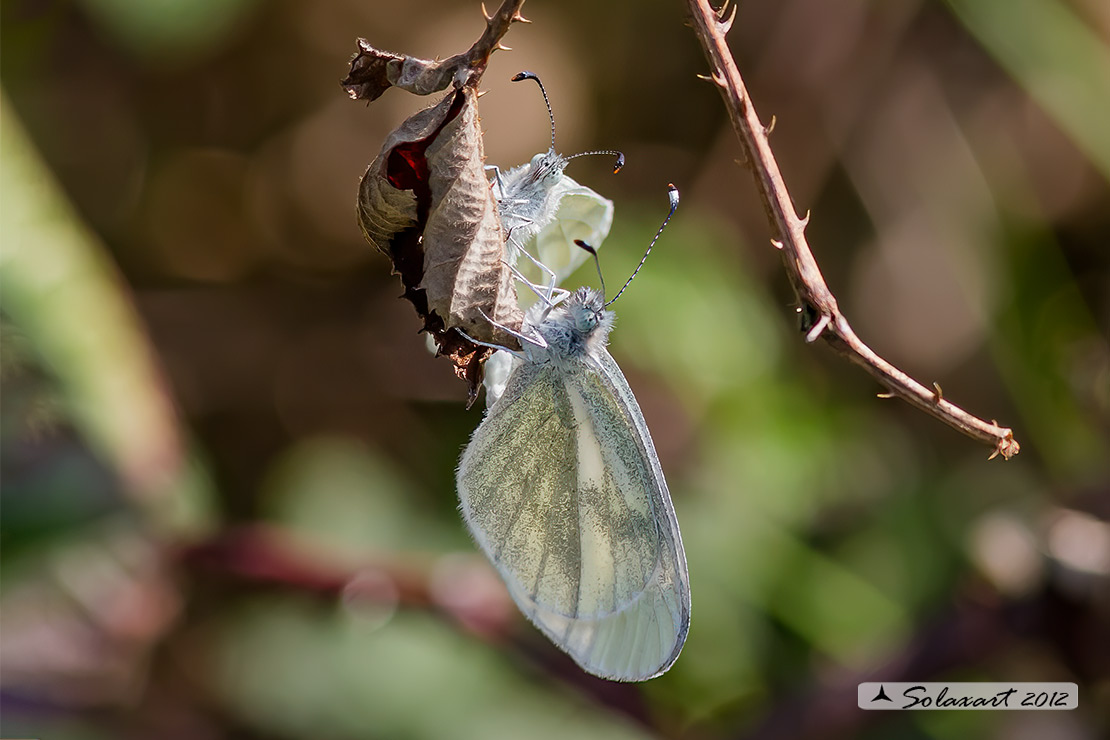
[0,92,208,531]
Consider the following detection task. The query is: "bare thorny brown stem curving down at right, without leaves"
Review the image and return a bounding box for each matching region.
[688,0,1020,459]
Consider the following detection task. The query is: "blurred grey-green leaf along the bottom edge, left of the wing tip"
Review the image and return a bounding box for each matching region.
[211,599,646,740]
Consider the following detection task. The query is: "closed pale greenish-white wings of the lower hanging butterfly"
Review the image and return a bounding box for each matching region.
[457,351,690,681]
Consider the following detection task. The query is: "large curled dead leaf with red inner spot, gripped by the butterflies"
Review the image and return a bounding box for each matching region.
[359,87,524,402]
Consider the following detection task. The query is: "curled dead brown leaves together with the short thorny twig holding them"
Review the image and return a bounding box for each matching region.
[342,0,528,403]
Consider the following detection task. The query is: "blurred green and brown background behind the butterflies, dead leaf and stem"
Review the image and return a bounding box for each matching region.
[0,0,1110,740]
